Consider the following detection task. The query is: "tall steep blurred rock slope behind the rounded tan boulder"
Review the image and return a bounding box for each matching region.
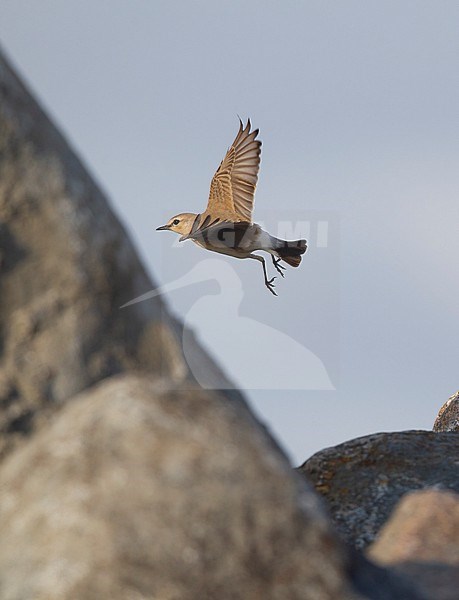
[0,50,241,456]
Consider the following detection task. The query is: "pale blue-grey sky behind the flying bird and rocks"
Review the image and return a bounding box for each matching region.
[0,0,459,464]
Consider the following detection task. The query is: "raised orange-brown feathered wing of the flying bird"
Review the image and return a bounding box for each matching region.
[205,119,261,222]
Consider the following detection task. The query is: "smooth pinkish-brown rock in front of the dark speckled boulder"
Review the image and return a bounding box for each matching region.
[367,490,459,600]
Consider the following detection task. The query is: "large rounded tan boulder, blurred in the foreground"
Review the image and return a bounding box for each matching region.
[0,375,362,600]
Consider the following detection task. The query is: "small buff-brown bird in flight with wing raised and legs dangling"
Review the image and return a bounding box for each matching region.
[156,119,307,296]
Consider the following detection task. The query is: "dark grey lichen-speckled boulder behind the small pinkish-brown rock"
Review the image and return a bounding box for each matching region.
[300,431,459,549]
